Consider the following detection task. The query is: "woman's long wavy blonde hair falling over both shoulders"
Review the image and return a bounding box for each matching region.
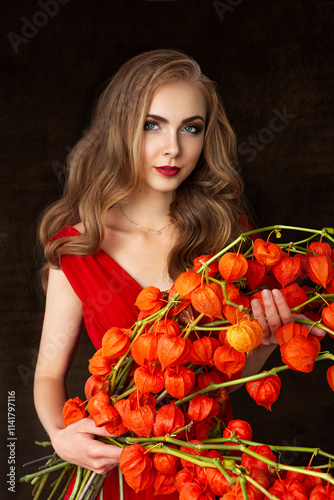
[39,50,243,286]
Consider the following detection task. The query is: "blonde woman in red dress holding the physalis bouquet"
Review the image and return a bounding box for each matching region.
[35,50,318,498]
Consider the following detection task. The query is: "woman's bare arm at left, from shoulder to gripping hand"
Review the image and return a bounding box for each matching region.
[34,269,121,474]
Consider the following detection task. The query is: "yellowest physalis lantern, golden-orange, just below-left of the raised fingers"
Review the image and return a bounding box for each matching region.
[226,319,263,352]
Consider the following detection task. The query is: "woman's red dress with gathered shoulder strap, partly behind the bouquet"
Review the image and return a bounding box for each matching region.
[55,226,232,500]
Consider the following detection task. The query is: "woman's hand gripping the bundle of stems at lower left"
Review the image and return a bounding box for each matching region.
[51,418,122,474]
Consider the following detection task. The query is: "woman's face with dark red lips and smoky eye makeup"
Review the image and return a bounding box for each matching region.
[142,81,206,193]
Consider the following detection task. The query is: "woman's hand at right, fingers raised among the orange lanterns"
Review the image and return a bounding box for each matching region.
[251,289,324,345]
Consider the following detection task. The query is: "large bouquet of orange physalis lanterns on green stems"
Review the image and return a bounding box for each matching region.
[21,226,334,500]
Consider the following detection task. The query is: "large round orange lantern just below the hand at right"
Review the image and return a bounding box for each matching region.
[280,336,317,373]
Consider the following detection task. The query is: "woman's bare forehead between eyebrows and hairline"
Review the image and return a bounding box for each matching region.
[149,81,206,119]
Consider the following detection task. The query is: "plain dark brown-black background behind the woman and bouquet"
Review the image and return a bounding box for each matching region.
[0,0,334,499]
